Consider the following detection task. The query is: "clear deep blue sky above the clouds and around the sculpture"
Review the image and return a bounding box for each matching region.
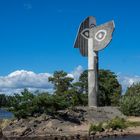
[0,0,140,93]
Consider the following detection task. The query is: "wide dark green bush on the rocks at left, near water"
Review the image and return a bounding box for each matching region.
[9,90,70,119]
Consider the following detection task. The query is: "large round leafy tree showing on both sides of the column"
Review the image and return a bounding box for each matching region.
[75,70,121,106]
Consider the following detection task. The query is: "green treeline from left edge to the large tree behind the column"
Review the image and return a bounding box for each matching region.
[0,70,121,118]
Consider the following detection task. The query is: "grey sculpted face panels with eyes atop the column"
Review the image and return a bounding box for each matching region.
[75,17,115,53]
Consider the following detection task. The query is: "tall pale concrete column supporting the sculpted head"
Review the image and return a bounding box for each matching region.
[88,38,98,107]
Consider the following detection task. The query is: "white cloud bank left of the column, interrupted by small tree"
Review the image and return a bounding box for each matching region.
[0,66,83,94]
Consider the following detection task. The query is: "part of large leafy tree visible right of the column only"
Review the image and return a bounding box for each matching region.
[98,70,122,106]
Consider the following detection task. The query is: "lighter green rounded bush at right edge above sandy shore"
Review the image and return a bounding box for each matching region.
[120,95,140,116]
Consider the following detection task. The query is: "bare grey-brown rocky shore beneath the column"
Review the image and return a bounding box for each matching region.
[3,106,126,138]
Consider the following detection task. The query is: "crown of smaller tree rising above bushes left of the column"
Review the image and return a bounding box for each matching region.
[49,71,73,95]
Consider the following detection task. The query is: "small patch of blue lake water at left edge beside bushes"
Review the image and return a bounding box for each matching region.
[0,109,13,119]
